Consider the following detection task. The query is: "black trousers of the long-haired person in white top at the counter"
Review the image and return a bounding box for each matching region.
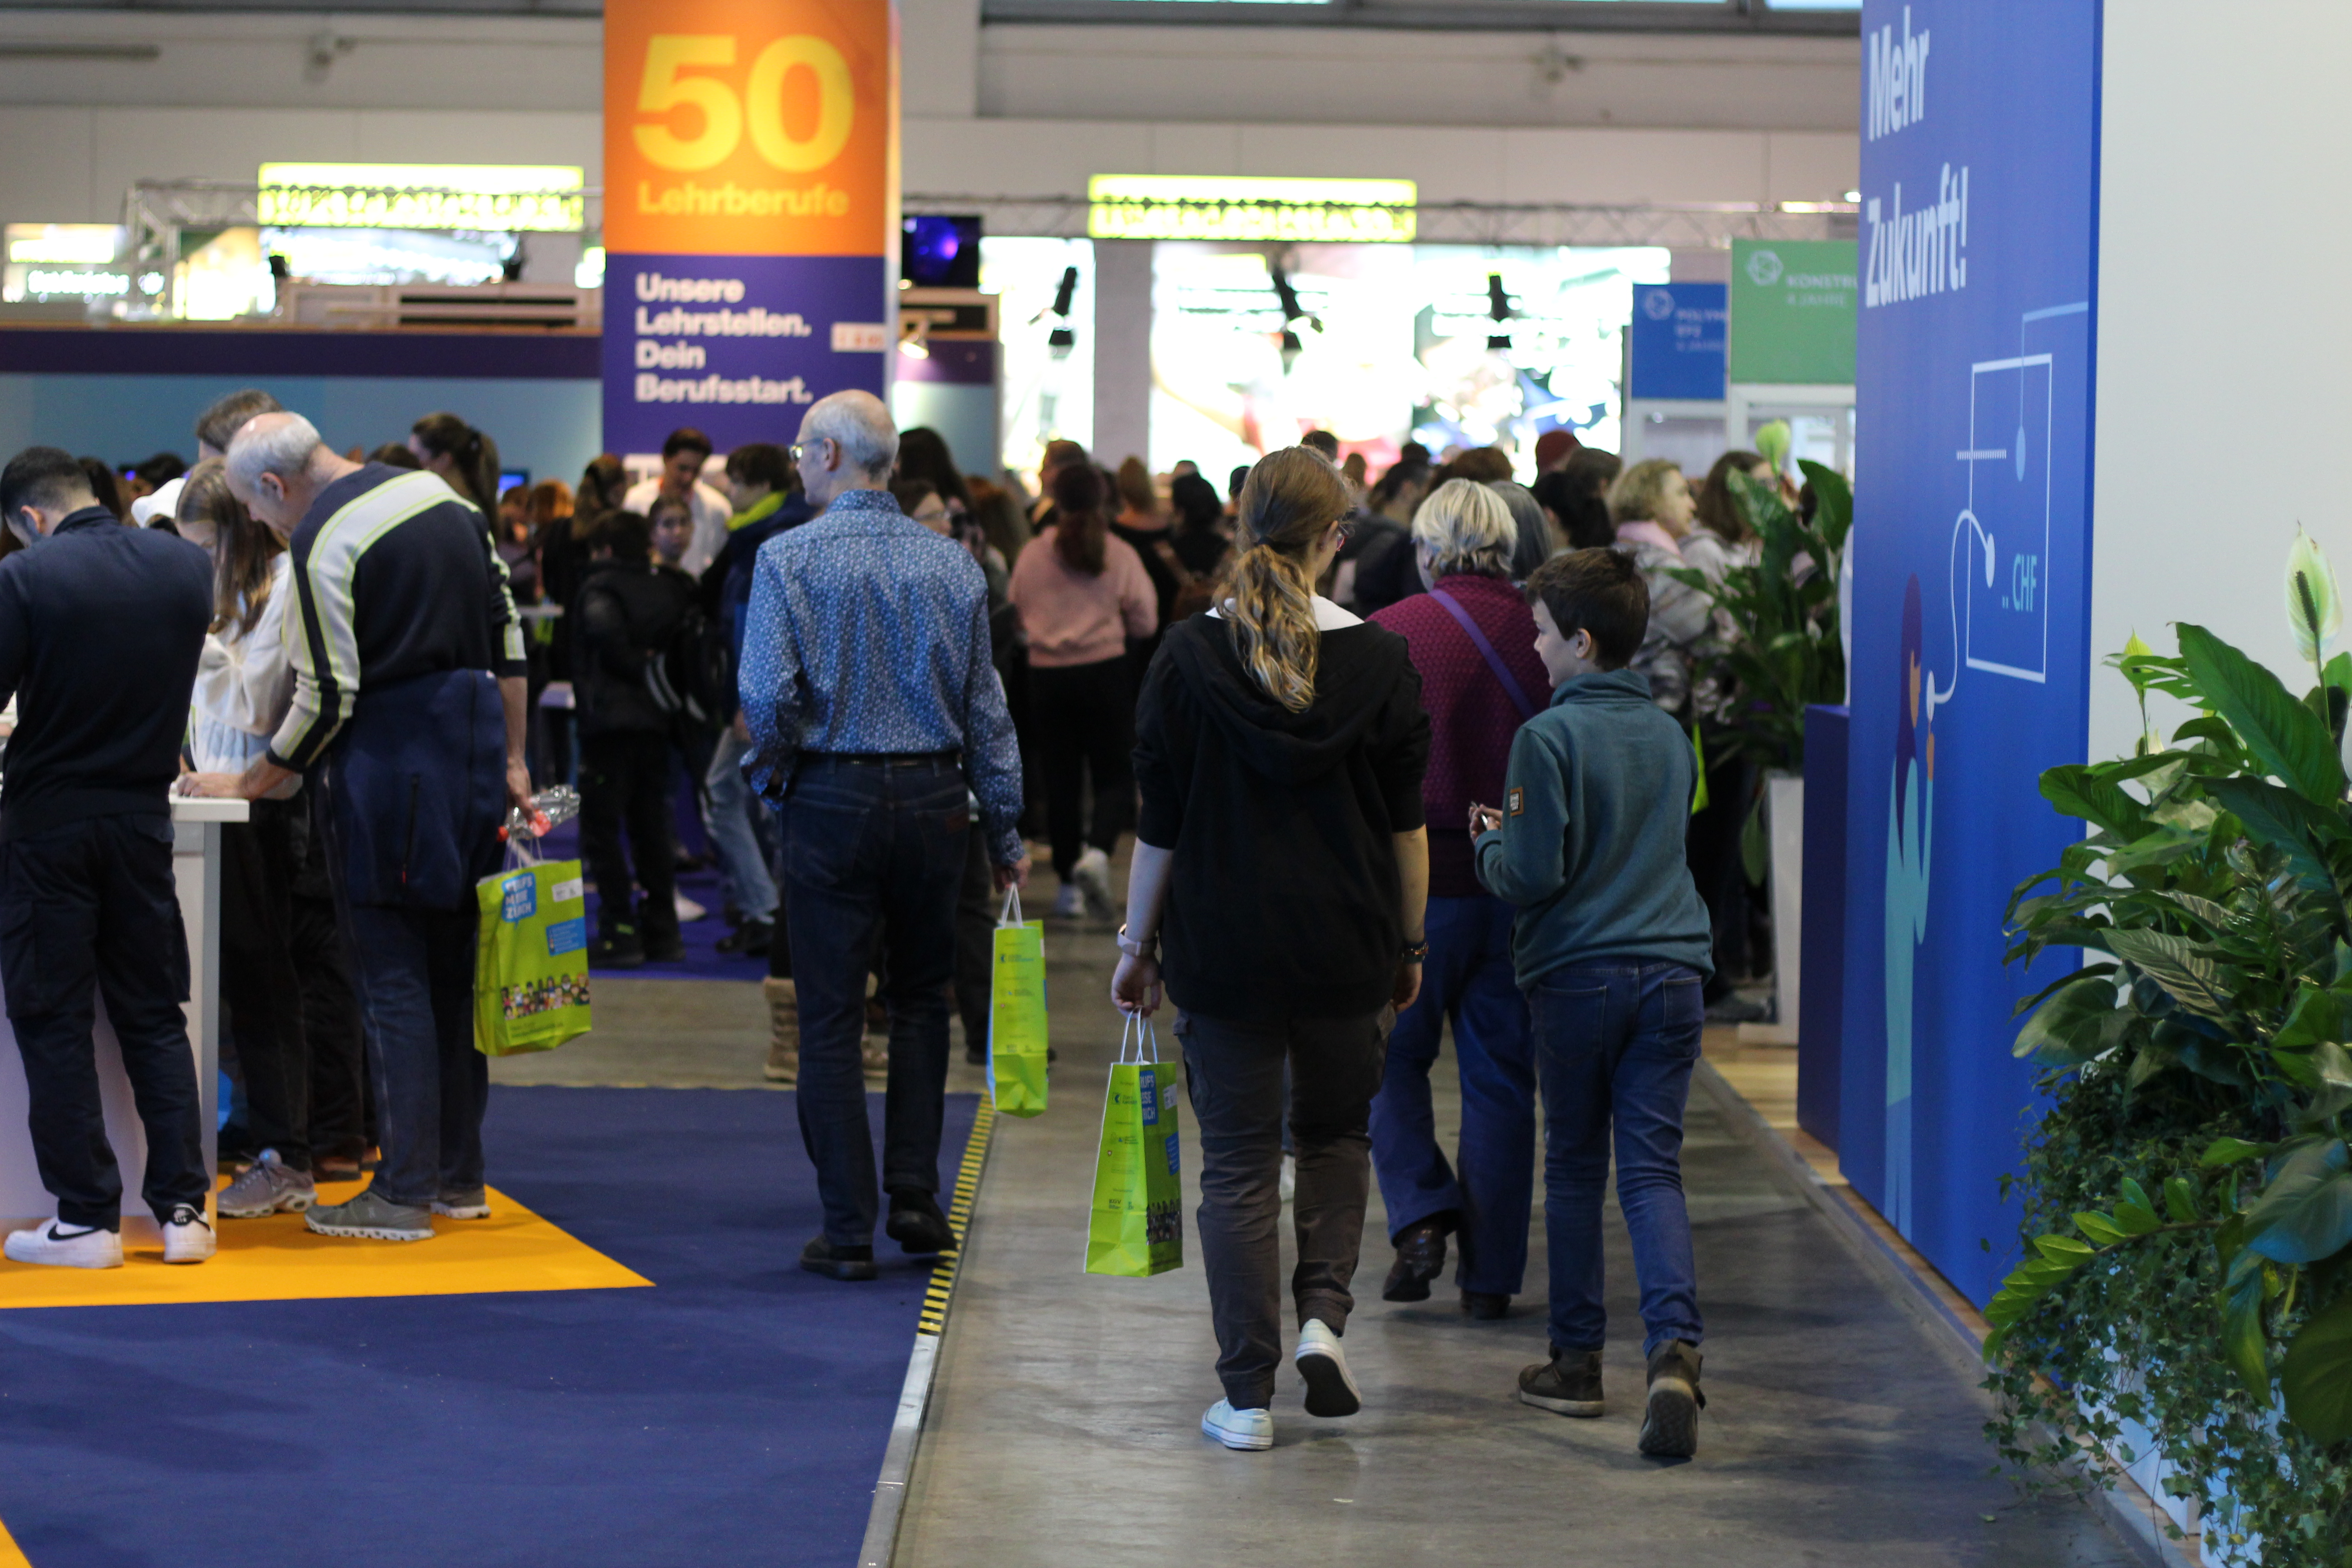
[221,799,310,1171]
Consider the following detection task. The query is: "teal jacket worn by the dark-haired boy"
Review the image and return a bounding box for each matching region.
[1477,670,1715,985]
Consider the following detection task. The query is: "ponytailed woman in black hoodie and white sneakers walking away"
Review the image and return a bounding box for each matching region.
[1110,446,1430,1448]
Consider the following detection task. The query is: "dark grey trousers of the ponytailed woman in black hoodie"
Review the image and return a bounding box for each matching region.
[1176,1009,1390,1411]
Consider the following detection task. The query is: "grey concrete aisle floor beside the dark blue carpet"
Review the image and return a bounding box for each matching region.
[896,929,2138,1568]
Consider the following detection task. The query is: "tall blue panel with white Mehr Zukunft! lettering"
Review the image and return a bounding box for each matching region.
[1839,0,2098,1303]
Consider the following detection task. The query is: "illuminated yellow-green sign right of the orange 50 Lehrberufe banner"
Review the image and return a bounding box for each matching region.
[1087,174,1416,245]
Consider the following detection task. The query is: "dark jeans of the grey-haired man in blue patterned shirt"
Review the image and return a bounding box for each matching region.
[783,757,971,1246]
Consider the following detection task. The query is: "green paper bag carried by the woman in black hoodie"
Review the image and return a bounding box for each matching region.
[1087,1015,1183,1279]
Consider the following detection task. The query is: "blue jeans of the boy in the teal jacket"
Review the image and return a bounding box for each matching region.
[1526,961,1705,1354]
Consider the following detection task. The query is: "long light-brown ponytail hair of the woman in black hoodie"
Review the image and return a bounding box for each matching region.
[1228,446,1355,712]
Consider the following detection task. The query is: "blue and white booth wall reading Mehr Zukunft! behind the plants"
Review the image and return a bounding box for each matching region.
[1837,0,2352,1303]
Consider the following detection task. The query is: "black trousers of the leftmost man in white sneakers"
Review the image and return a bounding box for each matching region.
[0,813,212,1230]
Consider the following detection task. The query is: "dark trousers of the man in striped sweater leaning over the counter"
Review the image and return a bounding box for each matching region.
[346,903,489,1208]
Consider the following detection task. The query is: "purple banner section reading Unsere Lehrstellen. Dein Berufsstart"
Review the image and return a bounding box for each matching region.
[604,256,894,456]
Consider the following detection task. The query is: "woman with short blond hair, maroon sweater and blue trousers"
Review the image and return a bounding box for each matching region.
[1371,480,1552,1319]
